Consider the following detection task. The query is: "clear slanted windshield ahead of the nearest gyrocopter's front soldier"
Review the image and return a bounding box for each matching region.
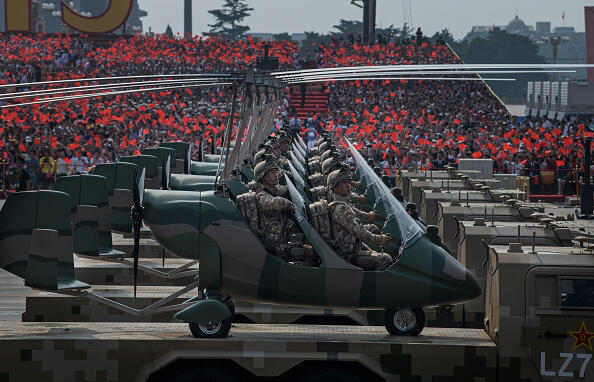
[346,140,423,250]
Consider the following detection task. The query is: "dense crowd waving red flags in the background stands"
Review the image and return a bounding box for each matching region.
[0,34,594,193]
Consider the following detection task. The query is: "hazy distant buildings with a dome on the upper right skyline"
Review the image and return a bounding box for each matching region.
[464,15,586,80]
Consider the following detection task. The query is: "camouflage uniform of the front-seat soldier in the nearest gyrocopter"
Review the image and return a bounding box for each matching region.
[330,195,392,271]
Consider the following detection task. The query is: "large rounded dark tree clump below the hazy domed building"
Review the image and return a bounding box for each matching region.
[454,29,548,102]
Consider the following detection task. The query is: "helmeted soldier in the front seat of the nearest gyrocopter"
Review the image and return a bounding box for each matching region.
[328,167,392,271]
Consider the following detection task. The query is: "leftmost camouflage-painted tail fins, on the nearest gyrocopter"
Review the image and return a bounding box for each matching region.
[0,191,89,291]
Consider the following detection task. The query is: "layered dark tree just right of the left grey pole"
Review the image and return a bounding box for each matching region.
[208,0,254,40]
